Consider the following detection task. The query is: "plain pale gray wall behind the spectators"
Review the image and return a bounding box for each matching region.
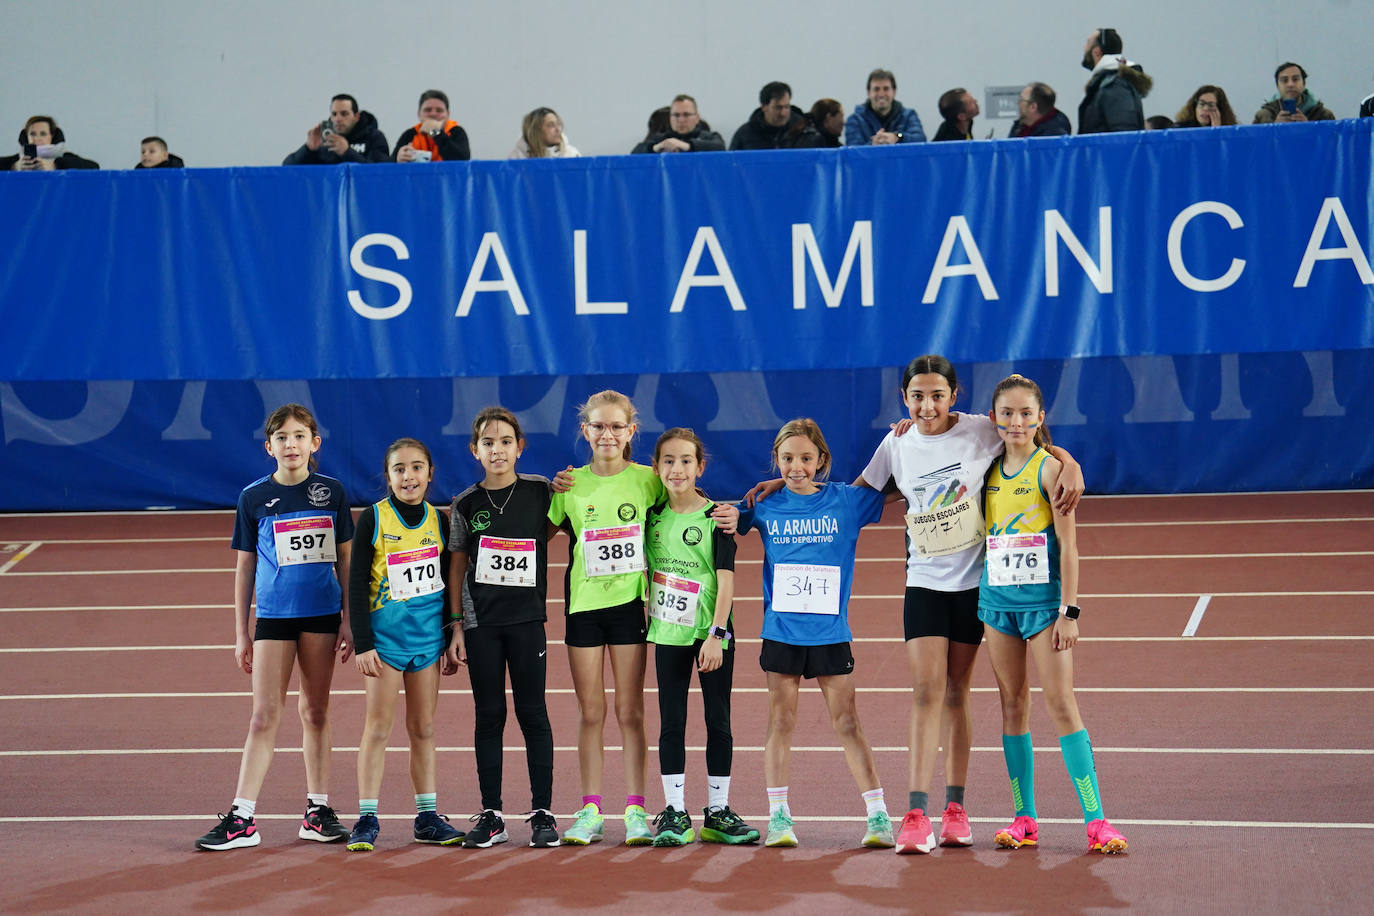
[0,0,1374,168]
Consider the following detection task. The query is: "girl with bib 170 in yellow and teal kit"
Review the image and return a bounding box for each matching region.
[348,438,463,850]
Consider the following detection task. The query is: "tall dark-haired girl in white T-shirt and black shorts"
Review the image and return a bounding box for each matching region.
[855,356,1083,853]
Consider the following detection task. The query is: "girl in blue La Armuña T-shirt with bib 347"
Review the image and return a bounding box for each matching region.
[739,419,893,847]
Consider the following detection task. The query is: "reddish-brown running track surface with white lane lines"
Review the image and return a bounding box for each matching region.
[0,493,1374,913]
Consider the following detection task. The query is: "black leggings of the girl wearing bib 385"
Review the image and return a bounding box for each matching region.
[654,640,735,776]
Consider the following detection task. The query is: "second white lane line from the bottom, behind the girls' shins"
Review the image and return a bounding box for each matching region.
[0,744,1374,758]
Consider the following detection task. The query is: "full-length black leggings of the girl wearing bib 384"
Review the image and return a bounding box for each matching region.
[463,621,554,810]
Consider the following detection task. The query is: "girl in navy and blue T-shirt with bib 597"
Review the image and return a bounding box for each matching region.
[195,404,353,850]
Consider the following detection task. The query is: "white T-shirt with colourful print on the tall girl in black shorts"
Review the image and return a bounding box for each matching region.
[863,412,1002,592]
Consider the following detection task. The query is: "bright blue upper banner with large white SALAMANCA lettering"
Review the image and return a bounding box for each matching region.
[0,119,1374,382]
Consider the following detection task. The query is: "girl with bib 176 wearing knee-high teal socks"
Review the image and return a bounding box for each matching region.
[978,375,1127,853]
